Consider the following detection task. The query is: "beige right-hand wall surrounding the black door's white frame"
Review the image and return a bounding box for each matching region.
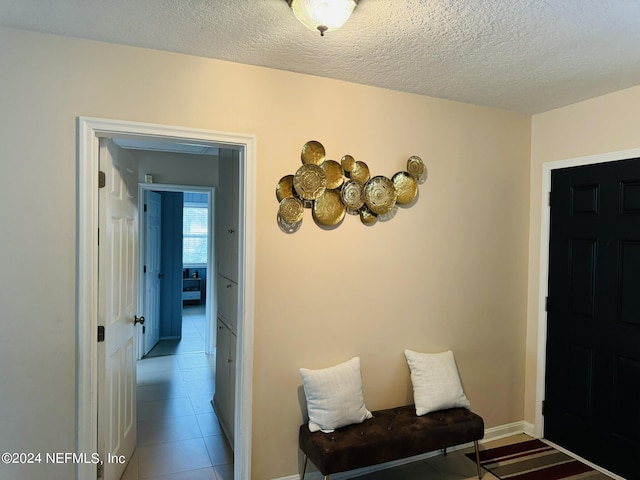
[525,87,640,423]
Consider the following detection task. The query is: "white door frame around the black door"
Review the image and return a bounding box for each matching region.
[534,148,640,438]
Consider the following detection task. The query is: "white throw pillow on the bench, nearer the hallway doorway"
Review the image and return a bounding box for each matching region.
[300,357,372,433]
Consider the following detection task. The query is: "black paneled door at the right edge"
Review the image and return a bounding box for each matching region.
[544,159,640,479]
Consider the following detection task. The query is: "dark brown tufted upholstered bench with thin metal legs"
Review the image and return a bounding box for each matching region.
[298,405,484,479]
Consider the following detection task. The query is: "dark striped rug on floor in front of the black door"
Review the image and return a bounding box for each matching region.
[467,439,610,480]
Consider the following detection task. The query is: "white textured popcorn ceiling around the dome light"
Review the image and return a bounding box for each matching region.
[0,0,640,113]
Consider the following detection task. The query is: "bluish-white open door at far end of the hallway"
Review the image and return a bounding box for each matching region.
[143,190,162,355]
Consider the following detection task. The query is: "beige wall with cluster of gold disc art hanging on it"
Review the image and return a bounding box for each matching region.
[0,29,531,479]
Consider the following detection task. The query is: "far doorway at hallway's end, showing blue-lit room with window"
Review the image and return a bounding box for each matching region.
[137,184,217,359]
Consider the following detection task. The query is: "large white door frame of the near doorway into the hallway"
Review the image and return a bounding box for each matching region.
[76,117,256,480]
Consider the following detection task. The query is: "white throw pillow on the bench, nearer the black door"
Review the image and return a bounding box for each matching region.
[404,350,471,416]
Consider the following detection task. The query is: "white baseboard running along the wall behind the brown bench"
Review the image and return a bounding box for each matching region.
[273,420,533,480]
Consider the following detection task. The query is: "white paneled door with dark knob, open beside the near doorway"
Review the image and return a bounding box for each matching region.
[98,139,138,480]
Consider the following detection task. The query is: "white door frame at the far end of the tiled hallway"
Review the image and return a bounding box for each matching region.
[136,183,217,360]
